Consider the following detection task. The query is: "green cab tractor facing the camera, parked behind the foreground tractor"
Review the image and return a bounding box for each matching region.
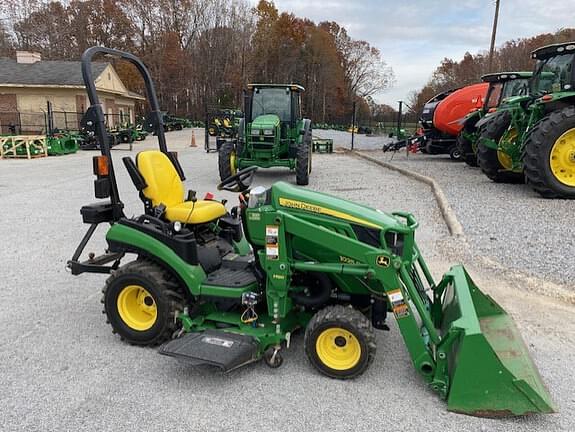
[218,84,313,185]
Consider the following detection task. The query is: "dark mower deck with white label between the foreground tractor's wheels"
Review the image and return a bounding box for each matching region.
[160,330,258,372]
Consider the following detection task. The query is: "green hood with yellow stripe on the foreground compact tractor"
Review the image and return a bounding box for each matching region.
[271,182,415,232]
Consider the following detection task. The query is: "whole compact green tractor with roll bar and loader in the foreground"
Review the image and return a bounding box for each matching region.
[68,47,555,415]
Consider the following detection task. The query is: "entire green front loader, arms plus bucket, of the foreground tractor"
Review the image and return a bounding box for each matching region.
[248,192,555,416]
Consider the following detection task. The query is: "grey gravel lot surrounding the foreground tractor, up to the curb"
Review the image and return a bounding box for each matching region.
[0,130,575,432]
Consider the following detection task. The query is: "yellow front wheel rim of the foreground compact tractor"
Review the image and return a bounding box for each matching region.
[315,327,361,370]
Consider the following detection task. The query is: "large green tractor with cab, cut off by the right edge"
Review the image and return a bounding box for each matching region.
[478,42,575,198]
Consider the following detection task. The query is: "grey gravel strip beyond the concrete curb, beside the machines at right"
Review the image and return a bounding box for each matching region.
[369,148,575,291]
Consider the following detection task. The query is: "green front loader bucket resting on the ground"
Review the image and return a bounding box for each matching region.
[438,266,556,417]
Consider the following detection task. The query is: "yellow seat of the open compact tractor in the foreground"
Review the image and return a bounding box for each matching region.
[136,150,226,224]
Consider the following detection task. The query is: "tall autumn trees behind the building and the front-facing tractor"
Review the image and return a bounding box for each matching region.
[0,0,393,123]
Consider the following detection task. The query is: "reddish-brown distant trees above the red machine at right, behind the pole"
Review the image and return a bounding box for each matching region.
[408,28,575,113]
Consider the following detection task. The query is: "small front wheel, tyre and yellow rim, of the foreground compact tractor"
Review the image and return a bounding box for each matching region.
[304,305,376,379]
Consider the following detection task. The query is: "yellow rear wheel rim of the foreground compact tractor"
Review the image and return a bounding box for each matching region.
[117,285,158,331]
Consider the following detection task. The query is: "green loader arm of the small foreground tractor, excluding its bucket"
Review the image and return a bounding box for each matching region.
[268,211,440,382]
